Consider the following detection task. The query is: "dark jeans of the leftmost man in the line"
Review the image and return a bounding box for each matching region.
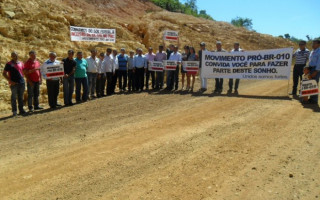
[10,83,25,113]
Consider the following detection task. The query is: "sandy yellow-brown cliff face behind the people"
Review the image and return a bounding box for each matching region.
[0,0,294,110]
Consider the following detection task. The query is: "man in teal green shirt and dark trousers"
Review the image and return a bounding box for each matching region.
[74,51,88,103]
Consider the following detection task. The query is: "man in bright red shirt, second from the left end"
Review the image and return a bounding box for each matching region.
[23,51,42,112]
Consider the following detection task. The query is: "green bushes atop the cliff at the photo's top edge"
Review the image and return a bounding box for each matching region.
[151,0,213,20]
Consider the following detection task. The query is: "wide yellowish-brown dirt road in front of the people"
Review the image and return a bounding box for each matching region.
[0,81,320,200]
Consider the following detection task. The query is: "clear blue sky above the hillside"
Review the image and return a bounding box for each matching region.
[182,0,320,39]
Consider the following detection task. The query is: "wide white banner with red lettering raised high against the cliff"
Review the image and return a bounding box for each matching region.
[70,26,116,43]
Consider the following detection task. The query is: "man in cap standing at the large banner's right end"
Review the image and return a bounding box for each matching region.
[290,41,310,95]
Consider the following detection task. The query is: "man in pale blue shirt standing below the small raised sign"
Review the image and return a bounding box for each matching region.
[167,46,182,90]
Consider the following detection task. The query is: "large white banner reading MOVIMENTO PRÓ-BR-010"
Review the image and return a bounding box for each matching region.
[201,48,293,80]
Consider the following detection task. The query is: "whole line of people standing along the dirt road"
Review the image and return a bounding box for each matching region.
[3,40,320,116]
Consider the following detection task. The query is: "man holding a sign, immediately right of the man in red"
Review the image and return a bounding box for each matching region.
[42,52,61,109]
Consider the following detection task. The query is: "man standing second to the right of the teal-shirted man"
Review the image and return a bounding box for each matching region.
[96,53,106,98]
